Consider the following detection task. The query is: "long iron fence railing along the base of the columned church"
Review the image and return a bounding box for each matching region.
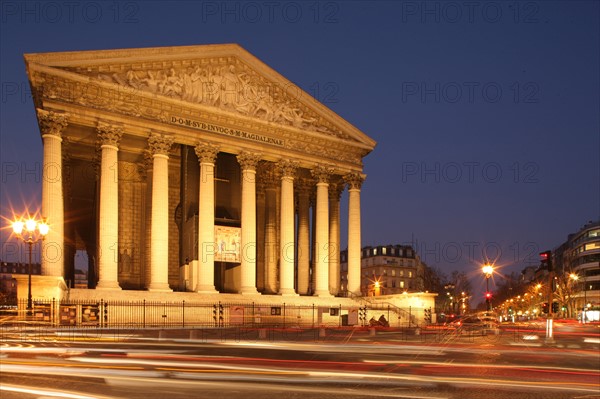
[0,300,422,328]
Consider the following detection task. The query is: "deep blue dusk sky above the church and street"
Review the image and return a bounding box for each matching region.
[0,1,600,296]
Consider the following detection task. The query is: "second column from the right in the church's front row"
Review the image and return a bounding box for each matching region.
[311,166,333,297]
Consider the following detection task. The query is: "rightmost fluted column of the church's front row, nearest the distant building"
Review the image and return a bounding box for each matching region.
[344,173,365,294]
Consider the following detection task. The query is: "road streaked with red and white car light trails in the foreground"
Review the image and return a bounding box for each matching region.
[0,326,600,399]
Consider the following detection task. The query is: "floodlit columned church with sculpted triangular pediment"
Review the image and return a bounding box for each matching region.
[25,44,375,304]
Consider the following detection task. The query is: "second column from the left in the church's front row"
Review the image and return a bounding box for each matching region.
[96,122,123,290]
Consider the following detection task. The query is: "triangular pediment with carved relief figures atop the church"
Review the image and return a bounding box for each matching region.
[25,44,375,153]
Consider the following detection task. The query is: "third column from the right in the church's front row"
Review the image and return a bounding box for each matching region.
[278,160,298,295]
